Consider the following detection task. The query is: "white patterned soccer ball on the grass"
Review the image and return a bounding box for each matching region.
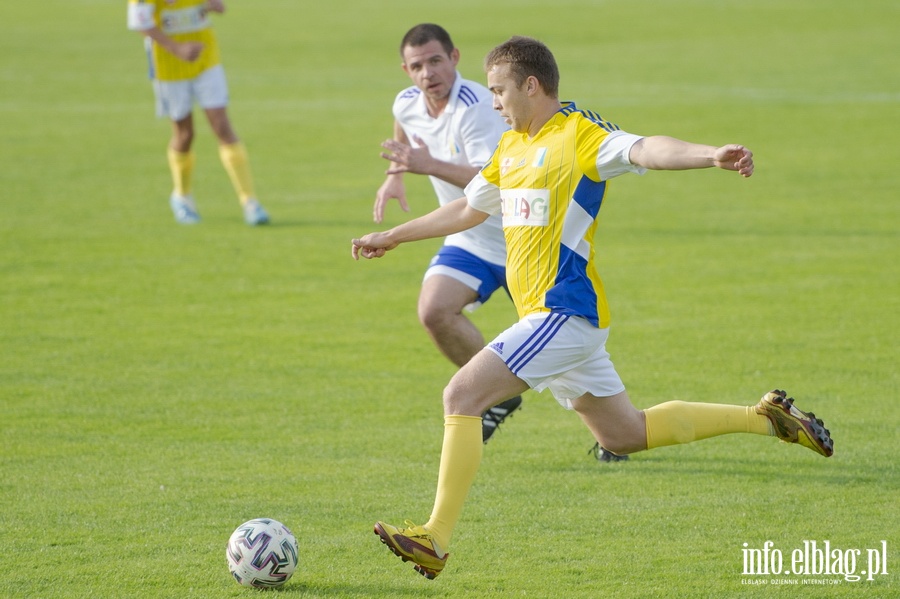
[225,518,298,589]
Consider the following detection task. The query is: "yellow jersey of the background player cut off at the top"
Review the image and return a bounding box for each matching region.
[128,0,221,81]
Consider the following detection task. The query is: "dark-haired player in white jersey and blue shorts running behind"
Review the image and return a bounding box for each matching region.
[374,23,522,443]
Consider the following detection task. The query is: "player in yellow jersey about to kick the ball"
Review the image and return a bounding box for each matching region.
[352,37,834,578]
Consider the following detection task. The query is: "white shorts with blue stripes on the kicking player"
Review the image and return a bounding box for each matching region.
[487,312,625,410]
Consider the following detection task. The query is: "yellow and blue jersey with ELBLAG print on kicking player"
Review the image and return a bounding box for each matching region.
[466,103,642,328]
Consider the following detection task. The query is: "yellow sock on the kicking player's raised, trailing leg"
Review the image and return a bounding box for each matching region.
[644,401,773,449]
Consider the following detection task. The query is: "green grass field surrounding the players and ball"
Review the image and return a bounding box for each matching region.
[0,0,900,599]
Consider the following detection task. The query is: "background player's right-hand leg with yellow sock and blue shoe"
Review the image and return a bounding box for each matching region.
[195,65,269,225]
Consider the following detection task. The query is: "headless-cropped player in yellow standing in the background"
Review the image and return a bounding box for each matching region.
[128,0,269,226]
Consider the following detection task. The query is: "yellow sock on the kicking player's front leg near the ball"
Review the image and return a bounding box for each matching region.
[425,415,484,551]
